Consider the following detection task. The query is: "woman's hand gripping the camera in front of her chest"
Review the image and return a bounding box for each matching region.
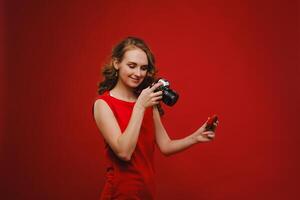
[135,82,163,109]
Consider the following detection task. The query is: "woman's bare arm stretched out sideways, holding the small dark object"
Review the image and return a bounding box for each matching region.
[153,106,217,155]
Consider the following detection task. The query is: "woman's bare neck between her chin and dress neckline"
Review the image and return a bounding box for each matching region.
[110,79,136,101]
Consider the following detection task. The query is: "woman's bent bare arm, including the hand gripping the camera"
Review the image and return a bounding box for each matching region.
[94,84,161,161]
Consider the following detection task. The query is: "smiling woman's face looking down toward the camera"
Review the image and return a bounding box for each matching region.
[114,48,148,88]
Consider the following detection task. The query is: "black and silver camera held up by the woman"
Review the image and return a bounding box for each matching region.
[155,78,179,106]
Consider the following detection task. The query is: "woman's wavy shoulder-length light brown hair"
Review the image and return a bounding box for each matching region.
[98,37,164,115]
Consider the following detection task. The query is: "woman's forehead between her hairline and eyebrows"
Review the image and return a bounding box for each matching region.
[123,48,148,65]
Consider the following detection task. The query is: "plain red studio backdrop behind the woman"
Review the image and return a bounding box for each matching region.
[0,0,300,200]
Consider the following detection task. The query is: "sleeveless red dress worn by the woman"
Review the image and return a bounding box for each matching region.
[97,92,155,200]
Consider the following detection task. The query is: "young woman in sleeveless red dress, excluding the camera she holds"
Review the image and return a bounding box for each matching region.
[93,37,217,200]
